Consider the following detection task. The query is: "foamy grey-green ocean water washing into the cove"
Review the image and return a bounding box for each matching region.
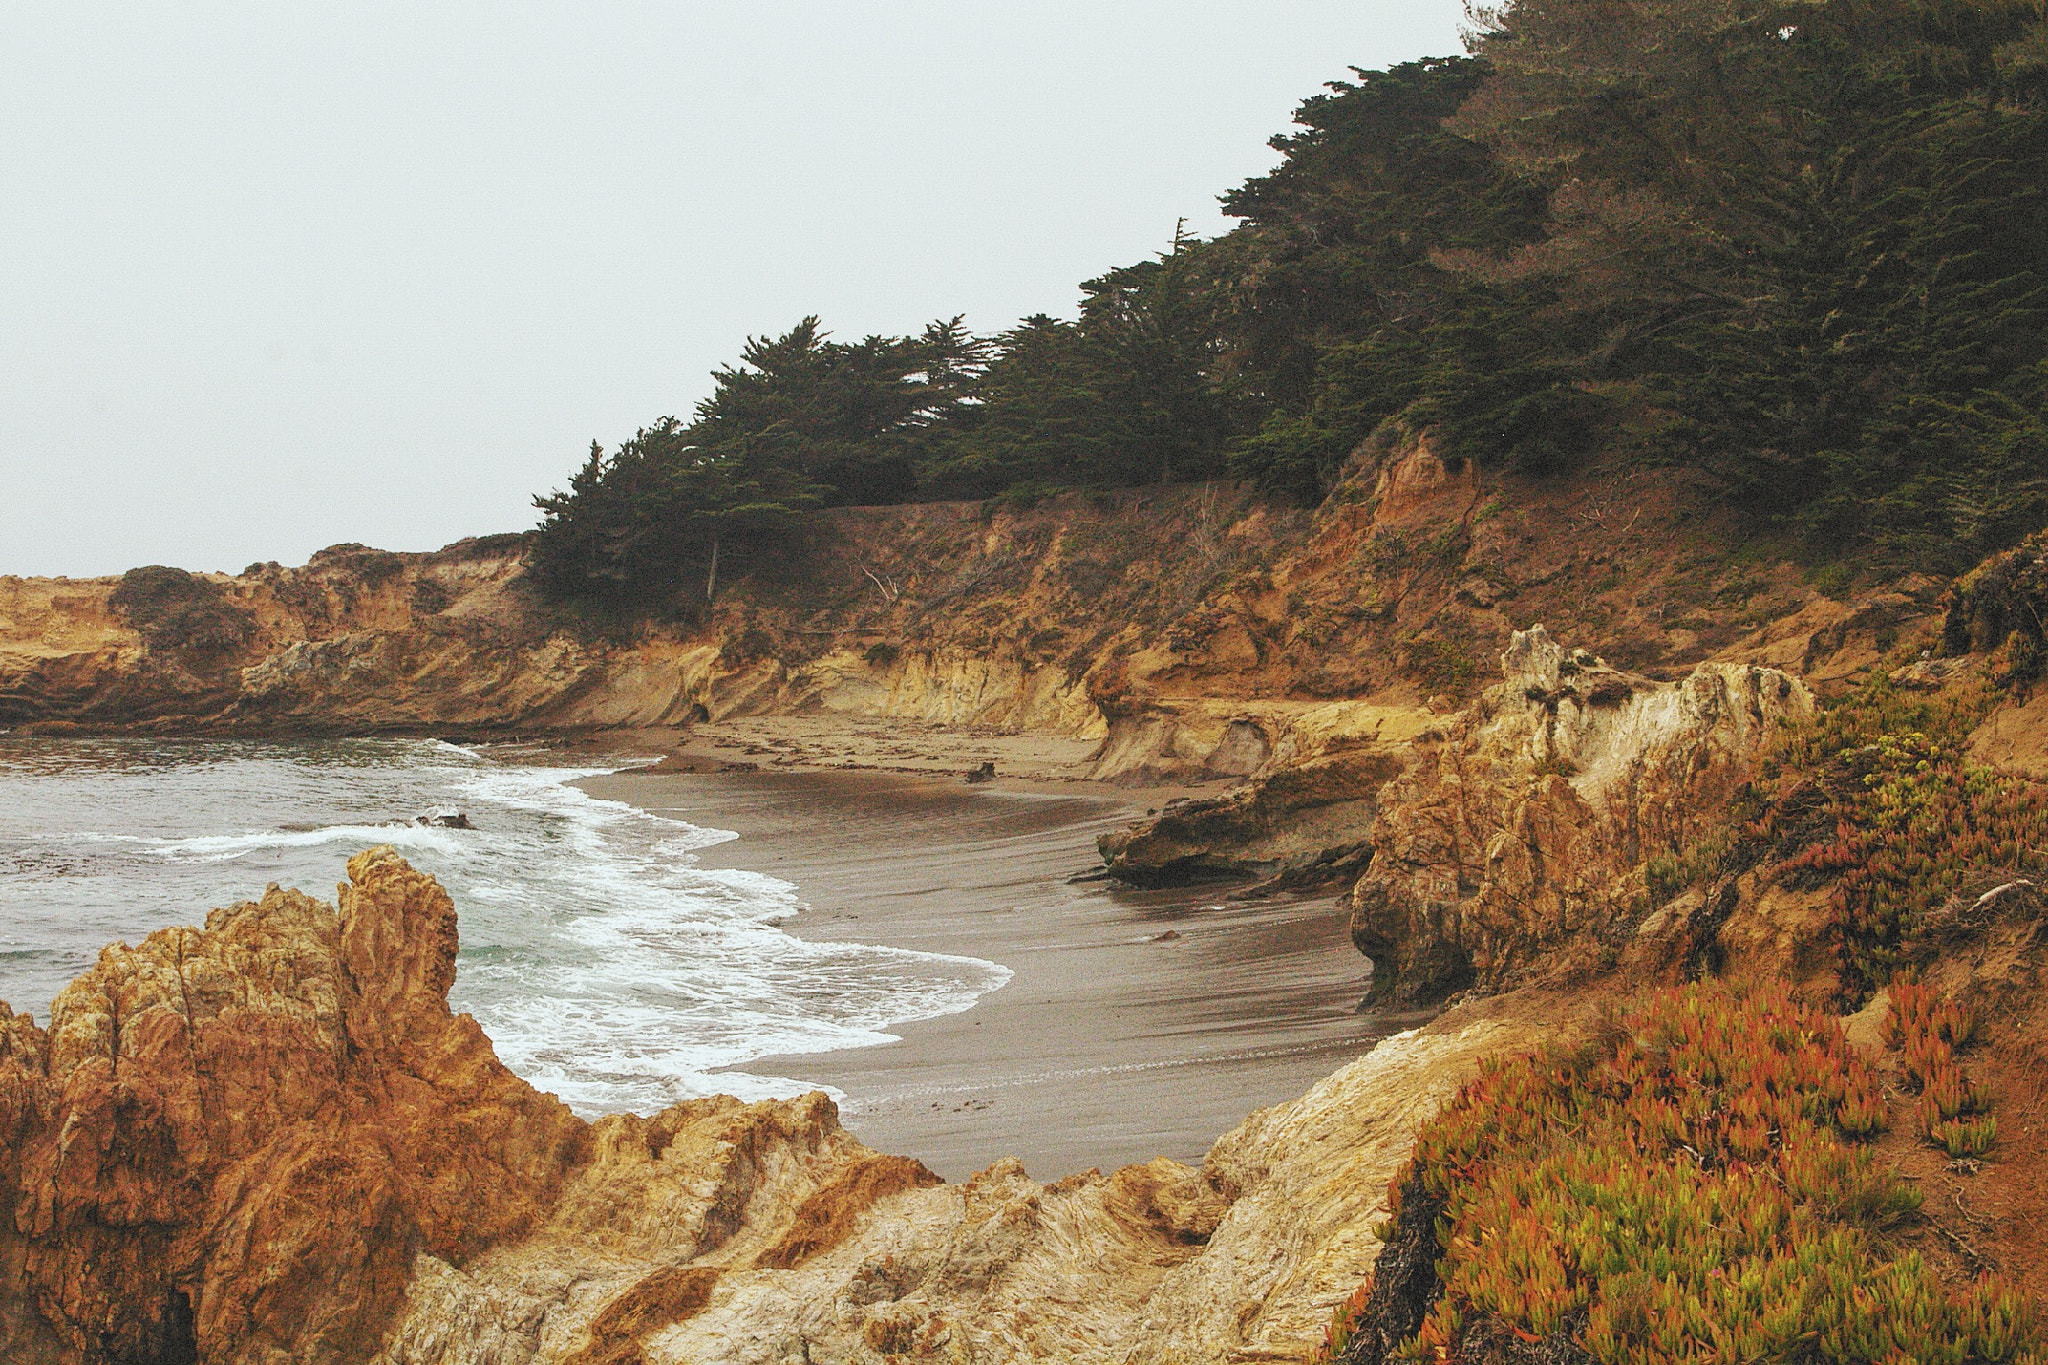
[0,735,1010,1115]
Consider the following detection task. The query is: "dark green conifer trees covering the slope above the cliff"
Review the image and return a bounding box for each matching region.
[537,0,2048,608]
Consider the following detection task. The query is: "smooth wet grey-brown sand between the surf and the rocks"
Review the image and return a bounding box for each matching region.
[582,772,1403,1179]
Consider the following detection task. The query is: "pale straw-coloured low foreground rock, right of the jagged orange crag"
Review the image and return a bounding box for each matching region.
[364,1002,1540,1365]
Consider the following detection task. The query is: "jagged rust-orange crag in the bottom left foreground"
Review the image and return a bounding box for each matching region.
[0,849,586,1365]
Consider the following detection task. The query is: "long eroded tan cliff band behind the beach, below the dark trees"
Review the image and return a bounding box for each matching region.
[0,440,1939,782]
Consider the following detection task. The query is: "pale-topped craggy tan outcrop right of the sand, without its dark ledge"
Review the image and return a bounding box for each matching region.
[1352,626,1812,1005]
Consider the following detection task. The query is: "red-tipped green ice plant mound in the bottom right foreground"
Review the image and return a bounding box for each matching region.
[1325,984,2040,1365]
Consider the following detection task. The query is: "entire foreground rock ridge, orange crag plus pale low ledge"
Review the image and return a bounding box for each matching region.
[0,849,1556,1365]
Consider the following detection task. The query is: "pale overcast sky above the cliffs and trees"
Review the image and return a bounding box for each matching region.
[0,0,1460,575]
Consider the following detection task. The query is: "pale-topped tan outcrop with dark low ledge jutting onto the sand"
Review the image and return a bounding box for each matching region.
[1100,626,1815,1009]
